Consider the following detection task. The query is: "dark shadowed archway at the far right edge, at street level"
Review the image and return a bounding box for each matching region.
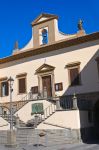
[94,100,99,138]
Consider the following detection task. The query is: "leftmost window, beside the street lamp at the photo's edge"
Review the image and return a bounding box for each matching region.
[1,81,9,97]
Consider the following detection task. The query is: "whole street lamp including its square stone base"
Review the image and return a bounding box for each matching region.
[5,77,17,147]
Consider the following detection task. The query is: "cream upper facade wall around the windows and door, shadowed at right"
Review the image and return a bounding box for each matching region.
[0,40,99,102]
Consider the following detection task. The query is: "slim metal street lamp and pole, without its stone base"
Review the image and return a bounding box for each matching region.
[8,76,14,131]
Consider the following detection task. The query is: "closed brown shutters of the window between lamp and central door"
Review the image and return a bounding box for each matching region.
[18,77,26,94]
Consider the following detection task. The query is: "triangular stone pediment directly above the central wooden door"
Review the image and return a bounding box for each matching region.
[35,64,55,74]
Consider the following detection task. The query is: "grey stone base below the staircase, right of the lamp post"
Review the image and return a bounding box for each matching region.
[17,128,73,146]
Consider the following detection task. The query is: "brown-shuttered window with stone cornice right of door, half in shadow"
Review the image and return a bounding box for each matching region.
[66,62,81,86]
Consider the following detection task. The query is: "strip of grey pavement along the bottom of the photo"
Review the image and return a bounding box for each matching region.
[0,143,99,150]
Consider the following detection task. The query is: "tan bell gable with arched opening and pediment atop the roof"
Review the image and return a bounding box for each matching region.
[32,14,58,48]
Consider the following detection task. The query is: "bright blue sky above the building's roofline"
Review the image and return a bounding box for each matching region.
[0,0,99,58]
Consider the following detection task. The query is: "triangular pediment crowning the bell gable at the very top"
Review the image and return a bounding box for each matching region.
[32,13,58,26]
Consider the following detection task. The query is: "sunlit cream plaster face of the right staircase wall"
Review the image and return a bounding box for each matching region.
[38,111,80,129]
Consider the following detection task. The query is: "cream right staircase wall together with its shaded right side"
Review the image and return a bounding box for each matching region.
[38,110,93,129]
